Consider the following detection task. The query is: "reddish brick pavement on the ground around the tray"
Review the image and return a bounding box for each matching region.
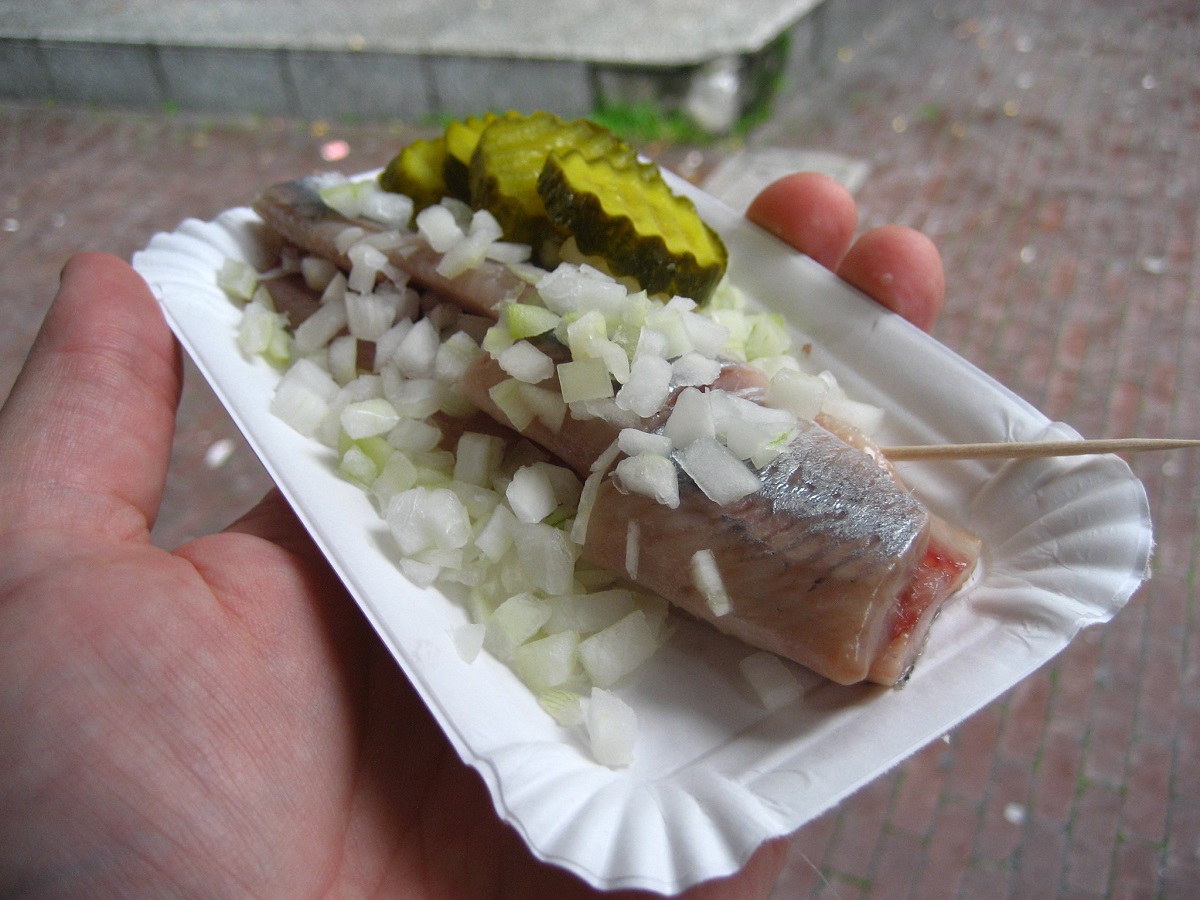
[0,0,1200,900]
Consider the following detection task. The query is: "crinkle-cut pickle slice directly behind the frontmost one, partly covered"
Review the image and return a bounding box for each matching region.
[470,113,635,253]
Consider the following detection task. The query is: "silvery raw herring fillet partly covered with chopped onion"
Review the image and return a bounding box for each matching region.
[254,179,979,685]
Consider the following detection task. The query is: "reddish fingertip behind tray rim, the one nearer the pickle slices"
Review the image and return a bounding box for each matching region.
[746,172,858,269]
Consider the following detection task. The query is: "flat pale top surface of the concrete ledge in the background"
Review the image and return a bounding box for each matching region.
[0,0,822,66]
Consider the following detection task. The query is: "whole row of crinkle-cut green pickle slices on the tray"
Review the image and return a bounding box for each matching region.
[379,112,728,302]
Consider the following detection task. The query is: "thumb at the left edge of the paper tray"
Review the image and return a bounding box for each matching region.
[0,253,182,536]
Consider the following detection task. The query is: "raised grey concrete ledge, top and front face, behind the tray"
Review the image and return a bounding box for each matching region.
[0,0,860,133]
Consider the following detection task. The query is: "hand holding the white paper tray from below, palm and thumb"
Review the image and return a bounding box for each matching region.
[0,174,940,899]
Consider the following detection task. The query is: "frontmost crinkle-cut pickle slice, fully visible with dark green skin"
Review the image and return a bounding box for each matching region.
[538,150,728,301]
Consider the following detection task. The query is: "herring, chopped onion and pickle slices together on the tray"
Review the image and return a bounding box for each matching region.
[231,114,978,745]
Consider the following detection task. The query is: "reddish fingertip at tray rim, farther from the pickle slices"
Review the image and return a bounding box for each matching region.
[838,226,946,331]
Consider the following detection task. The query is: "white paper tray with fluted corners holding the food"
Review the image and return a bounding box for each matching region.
[133,176,1152,893]
